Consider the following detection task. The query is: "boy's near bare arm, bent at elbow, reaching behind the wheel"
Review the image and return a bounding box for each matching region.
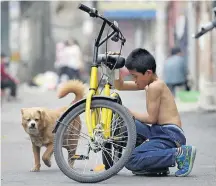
[130,84,161,124]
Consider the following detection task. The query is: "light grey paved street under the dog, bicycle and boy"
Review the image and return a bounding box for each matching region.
[1,85,216,186]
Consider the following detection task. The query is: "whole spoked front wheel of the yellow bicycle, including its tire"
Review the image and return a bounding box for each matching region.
[54,99,136,183]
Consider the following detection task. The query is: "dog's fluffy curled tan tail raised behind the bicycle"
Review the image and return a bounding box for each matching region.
[57,80,86,102]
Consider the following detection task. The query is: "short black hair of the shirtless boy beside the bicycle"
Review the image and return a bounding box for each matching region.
[125,48,156,74]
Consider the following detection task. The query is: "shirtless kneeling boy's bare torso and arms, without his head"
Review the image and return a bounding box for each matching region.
[115,77,181,127]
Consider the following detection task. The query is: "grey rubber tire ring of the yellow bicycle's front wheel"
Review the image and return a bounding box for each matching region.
[54,99,136,183]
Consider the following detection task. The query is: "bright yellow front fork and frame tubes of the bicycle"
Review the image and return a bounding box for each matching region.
[85,66,116,138]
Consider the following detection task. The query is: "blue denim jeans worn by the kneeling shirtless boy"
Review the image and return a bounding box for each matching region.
[125,120,186,171]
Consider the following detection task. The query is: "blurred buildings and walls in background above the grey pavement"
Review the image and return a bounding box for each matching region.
[1,0,216,109]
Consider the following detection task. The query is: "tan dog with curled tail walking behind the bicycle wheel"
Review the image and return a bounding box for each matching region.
[21,80,85,172]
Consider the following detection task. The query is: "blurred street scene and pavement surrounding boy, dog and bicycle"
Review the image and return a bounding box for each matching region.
[0,0,216,186]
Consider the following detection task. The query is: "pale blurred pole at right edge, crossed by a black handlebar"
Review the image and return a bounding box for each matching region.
[198,1,216,111]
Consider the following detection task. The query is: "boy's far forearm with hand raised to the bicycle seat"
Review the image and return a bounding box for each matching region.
[114,69,141,90]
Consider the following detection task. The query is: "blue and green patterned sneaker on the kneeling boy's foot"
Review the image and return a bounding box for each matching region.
[175,145,196,177]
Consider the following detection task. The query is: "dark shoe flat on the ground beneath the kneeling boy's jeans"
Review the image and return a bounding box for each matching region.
[132,168,170,176]
